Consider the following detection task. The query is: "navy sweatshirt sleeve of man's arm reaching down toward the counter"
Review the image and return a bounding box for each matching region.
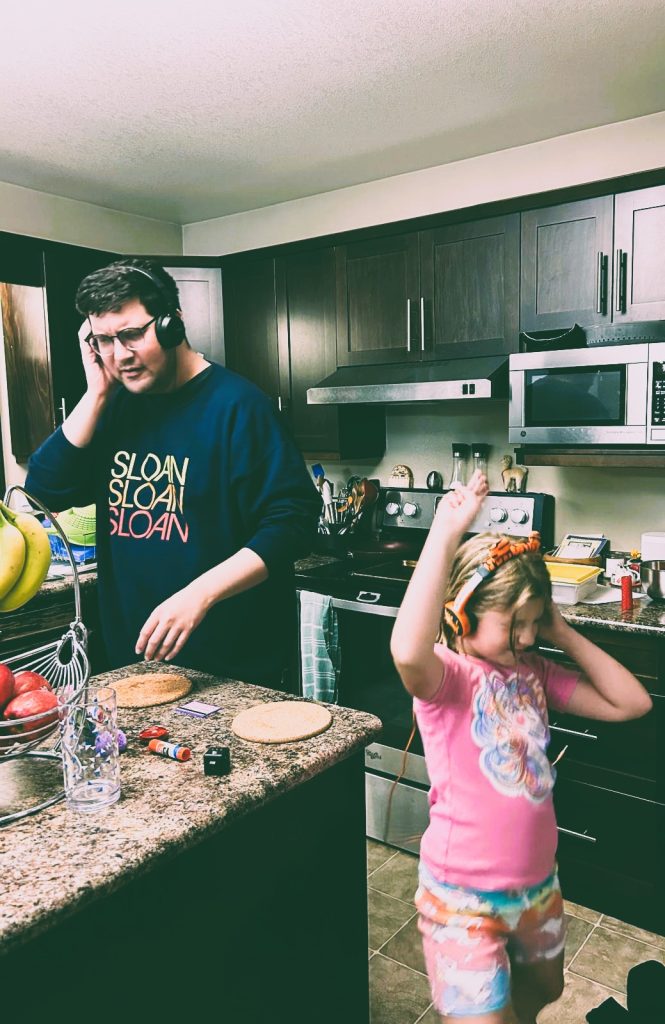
[231,395,321,573]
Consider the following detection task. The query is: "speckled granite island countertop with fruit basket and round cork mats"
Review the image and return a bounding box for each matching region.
[0,663,381,950]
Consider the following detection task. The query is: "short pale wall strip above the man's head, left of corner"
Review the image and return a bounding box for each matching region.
[0,181,182,255]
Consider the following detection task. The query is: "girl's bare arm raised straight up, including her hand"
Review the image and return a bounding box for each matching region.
[390,471,488,700]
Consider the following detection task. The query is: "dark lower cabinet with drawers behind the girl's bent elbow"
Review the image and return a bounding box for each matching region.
[543,629,665,934]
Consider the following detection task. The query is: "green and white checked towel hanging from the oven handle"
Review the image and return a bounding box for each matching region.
[300,590,341,703]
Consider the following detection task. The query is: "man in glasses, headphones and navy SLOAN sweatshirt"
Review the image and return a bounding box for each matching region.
[26,259,321,686]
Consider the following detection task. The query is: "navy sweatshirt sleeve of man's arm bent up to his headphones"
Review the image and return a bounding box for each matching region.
[26,427,95,512]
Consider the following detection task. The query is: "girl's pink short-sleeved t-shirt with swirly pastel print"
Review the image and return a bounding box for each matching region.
[414,644,580,890]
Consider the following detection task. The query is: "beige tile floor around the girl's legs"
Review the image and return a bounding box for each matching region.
[367,840,665,1024]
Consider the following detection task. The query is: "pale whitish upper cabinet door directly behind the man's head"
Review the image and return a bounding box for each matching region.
[164,266,224,365]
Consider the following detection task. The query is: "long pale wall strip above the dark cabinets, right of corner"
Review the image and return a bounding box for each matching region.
[182,112,665,256]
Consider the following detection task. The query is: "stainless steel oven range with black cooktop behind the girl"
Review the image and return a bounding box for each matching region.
[296,488,553,852]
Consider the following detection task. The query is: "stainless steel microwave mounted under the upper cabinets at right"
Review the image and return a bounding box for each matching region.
[508,342,665,445]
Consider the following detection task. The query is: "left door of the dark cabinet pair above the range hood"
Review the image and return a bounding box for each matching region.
[336,232,421,366]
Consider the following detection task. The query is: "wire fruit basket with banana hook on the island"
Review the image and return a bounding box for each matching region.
[0,484,90,825]
